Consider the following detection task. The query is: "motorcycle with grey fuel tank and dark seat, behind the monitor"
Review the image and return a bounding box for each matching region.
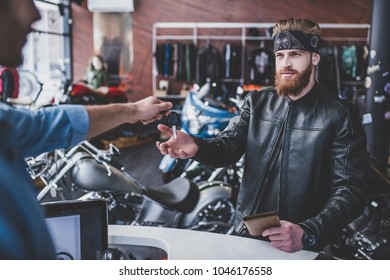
[26,141,234,234]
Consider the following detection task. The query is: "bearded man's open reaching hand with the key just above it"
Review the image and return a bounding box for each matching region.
[156,112,198,159]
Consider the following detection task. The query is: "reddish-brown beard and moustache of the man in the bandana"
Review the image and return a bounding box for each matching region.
[275,64,312,97]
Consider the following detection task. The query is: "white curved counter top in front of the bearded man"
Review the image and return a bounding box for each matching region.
[108,225,318,260]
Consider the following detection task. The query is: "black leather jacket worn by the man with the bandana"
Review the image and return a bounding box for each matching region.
[194,84,368,249]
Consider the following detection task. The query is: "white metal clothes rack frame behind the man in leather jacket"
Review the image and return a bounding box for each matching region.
[152,22,370,99]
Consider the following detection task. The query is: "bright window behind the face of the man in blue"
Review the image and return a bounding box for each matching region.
[19,0,72,104]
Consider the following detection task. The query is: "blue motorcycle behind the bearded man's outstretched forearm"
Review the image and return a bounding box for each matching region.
[159,81,243,185]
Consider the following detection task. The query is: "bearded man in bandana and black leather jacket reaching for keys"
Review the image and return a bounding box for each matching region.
[156,18,368,252]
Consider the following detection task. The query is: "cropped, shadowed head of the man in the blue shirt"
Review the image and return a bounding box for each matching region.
[0,0,40,67]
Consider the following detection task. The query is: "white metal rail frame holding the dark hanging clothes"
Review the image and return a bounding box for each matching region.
[152,22,370,96]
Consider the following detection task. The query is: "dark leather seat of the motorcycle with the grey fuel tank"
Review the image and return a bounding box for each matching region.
[145,177,199,213]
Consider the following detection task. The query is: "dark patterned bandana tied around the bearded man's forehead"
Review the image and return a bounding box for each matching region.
[274,30,321,53]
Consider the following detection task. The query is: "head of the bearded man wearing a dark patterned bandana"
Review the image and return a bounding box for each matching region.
[273,18,321,97]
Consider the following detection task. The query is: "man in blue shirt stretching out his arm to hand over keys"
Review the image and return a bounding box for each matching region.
[0,0,173,260]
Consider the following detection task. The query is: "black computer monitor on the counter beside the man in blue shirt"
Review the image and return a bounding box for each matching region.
[42,200,108,260]
